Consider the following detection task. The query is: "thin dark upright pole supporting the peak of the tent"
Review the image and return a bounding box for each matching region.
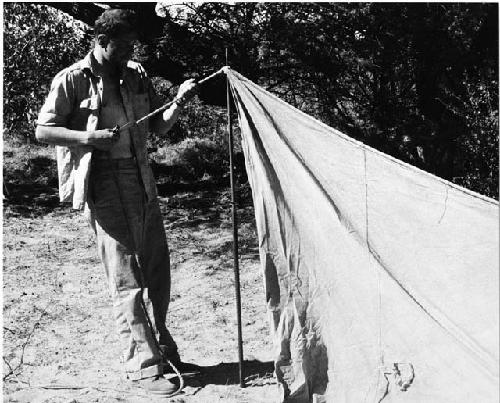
[226,48,245,388]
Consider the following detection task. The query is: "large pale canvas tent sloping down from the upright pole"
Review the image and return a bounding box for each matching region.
[227,70,499,403]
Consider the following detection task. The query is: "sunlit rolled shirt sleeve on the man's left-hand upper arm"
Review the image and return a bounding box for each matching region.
[37,70,75,126]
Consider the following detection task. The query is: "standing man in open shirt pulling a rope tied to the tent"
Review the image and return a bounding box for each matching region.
[36,9,196,396]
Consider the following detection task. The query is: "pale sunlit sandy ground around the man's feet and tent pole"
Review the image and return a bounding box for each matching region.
[3,188,279,403]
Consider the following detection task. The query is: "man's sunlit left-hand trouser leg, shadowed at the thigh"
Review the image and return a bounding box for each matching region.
[89,162,162,379]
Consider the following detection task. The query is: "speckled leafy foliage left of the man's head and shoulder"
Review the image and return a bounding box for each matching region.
[3,3,89,139]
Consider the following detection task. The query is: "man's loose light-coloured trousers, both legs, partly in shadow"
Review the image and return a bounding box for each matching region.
[88,158,177,379]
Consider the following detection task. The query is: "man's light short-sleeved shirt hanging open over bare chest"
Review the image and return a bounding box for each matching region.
[37,52,161,209]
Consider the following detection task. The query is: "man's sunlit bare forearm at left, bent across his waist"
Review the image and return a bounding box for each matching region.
[35,125,119,151]
